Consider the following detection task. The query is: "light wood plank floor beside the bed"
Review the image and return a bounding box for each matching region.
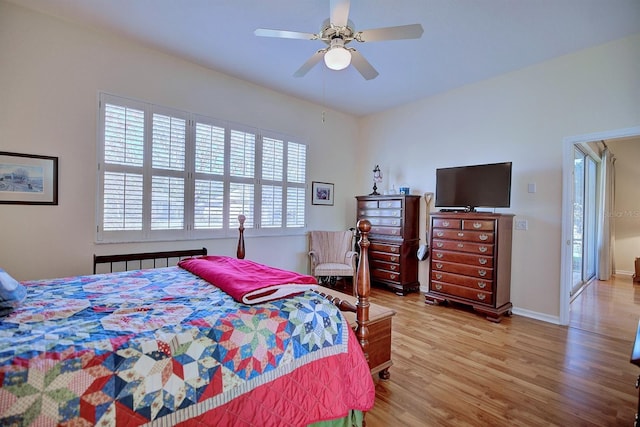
[356,276,640,427]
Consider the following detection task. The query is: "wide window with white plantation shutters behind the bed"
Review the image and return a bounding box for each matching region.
[97,94,307,242]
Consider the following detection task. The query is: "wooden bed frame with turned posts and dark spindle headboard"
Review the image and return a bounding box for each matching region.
[93,219,376,366]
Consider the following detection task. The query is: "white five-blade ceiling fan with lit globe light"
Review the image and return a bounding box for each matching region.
[254,0,423,80]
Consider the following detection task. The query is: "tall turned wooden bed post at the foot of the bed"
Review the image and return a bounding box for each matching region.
[355,219,371,362]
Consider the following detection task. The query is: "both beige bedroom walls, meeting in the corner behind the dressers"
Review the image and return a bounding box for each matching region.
[0,0,640,321]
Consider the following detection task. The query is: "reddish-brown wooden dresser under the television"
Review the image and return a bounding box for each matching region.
[425,212,513,322]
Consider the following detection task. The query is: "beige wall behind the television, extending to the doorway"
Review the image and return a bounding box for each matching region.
[361,35,640,321]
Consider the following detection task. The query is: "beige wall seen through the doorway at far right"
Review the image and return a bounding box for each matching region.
[607,137,640,274]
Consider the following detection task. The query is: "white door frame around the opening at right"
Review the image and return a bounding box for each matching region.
[560,126,640,325]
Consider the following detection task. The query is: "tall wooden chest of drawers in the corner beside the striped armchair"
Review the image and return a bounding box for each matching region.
[356,194,420,295]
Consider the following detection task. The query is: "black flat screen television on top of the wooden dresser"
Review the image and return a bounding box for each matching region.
[435,162,511,212]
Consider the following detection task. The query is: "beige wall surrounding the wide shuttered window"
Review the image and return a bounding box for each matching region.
[0,0,359,280]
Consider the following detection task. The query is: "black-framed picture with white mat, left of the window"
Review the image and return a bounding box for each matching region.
[0,151,58,205]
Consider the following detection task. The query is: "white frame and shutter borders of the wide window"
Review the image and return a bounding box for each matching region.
[95,92,309,243]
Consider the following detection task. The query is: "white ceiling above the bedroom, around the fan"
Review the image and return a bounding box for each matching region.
[10,0,640,116]
